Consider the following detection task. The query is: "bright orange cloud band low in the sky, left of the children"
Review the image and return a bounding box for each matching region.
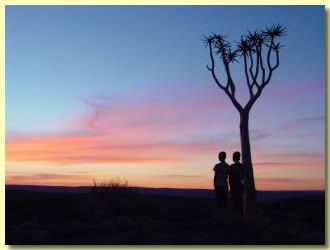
[6,132,222,165]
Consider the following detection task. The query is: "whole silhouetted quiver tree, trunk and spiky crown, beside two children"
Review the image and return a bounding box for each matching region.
[204,25,286,215]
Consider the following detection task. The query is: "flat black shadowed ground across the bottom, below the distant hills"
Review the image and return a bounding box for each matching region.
[6,190,325,245]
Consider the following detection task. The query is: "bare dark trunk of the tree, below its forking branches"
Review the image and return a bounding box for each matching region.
[240,110,257,216]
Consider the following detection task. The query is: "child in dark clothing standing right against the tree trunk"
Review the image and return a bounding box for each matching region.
[228,152,244,213]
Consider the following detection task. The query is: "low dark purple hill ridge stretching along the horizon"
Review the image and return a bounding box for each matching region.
[6,185,325,201]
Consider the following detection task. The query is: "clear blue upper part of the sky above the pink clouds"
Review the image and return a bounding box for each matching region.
[6,6,325,130]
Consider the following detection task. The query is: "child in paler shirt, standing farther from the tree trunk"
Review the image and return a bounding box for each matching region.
[213,152,229,208]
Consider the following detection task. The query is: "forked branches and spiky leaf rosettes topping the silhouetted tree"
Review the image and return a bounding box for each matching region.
[203,24,286,112]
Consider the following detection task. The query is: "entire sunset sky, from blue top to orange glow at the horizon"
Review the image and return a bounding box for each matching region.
[5,6,325,190]
